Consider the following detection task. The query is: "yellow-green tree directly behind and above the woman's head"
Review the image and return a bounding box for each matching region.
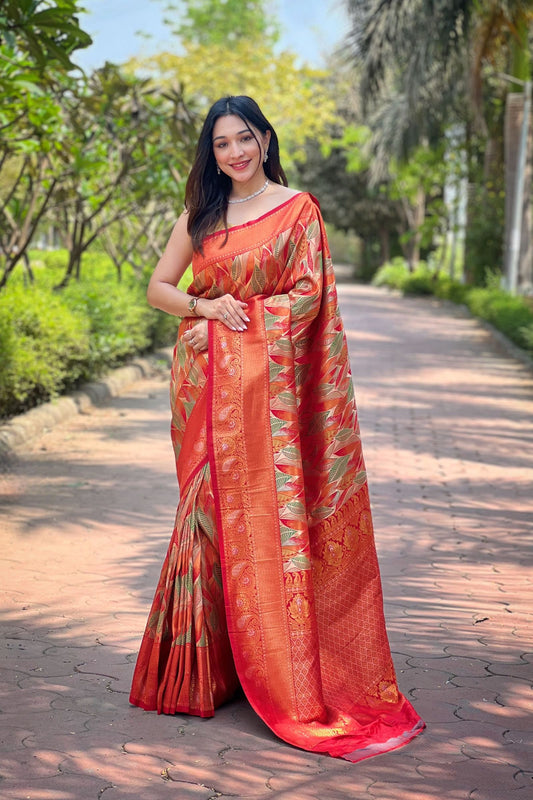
[128,0,335,165]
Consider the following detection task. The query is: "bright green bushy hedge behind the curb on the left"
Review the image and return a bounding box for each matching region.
[0,251,191,419]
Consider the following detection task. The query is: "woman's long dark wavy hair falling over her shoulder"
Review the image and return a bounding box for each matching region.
[185,95,287,252]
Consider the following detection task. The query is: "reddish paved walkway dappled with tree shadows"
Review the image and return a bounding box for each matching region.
[0,285,533,800]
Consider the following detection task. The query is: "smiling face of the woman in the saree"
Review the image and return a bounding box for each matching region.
[213,114,270,183]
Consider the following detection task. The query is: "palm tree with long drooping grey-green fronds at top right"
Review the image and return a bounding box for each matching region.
[346,0,533,282]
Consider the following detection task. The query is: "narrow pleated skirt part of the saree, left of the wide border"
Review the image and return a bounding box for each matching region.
[130,345,238,717]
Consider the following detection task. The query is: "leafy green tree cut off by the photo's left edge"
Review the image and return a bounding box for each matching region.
[0,0,91,288]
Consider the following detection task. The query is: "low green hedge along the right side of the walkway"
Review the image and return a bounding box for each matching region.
[372,258,533,354]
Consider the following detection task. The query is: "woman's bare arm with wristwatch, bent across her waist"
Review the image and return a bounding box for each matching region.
[146,211,249,331]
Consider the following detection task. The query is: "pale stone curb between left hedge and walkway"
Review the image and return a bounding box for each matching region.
[0,347,172,463]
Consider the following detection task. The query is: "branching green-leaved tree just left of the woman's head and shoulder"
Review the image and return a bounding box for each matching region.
[50,63,197,287]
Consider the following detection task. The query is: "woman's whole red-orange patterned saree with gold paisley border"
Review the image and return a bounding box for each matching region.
[130,193,424,762]
